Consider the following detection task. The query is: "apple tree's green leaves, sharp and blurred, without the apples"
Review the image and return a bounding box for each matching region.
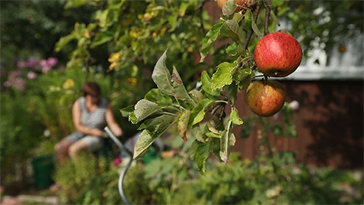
[57,0,364,172]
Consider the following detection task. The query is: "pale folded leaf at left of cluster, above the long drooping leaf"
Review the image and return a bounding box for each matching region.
[129,99,160,124]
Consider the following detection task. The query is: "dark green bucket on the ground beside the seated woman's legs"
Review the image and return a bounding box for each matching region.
[32,154,54,189]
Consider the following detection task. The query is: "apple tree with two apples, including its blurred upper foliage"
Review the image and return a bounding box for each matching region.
[56,0,357,172]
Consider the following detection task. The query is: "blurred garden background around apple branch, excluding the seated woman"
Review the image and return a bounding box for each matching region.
[0,0,364,204]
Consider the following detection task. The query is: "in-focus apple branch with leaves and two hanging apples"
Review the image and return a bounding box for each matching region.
[122,0,302,173]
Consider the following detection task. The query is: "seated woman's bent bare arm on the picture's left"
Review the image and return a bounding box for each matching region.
[72,100,104,137]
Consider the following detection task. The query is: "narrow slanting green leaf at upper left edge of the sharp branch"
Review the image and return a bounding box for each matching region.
[200,21,224,62]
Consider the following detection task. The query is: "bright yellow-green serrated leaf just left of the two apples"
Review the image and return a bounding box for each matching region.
[211,62,237,89]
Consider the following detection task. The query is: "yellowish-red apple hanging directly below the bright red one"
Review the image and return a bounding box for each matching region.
[245,81,285,117]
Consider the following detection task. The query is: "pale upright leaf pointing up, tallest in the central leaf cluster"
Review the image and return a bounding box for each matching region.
[152,51,173,95]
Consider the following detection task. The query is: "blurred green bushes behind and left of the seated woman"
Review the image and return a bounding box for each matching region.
[0,69,143,185]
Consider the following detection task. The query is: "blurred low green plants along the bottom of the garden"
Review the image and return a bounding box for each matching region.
[56,143,361,204]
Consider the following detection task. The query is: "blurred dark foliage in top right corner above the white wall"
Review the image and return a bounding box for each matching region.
[284,0,364,57]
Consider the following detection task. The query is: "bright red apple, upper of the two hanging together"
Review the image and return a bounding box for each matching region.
[254,32,302,77]
